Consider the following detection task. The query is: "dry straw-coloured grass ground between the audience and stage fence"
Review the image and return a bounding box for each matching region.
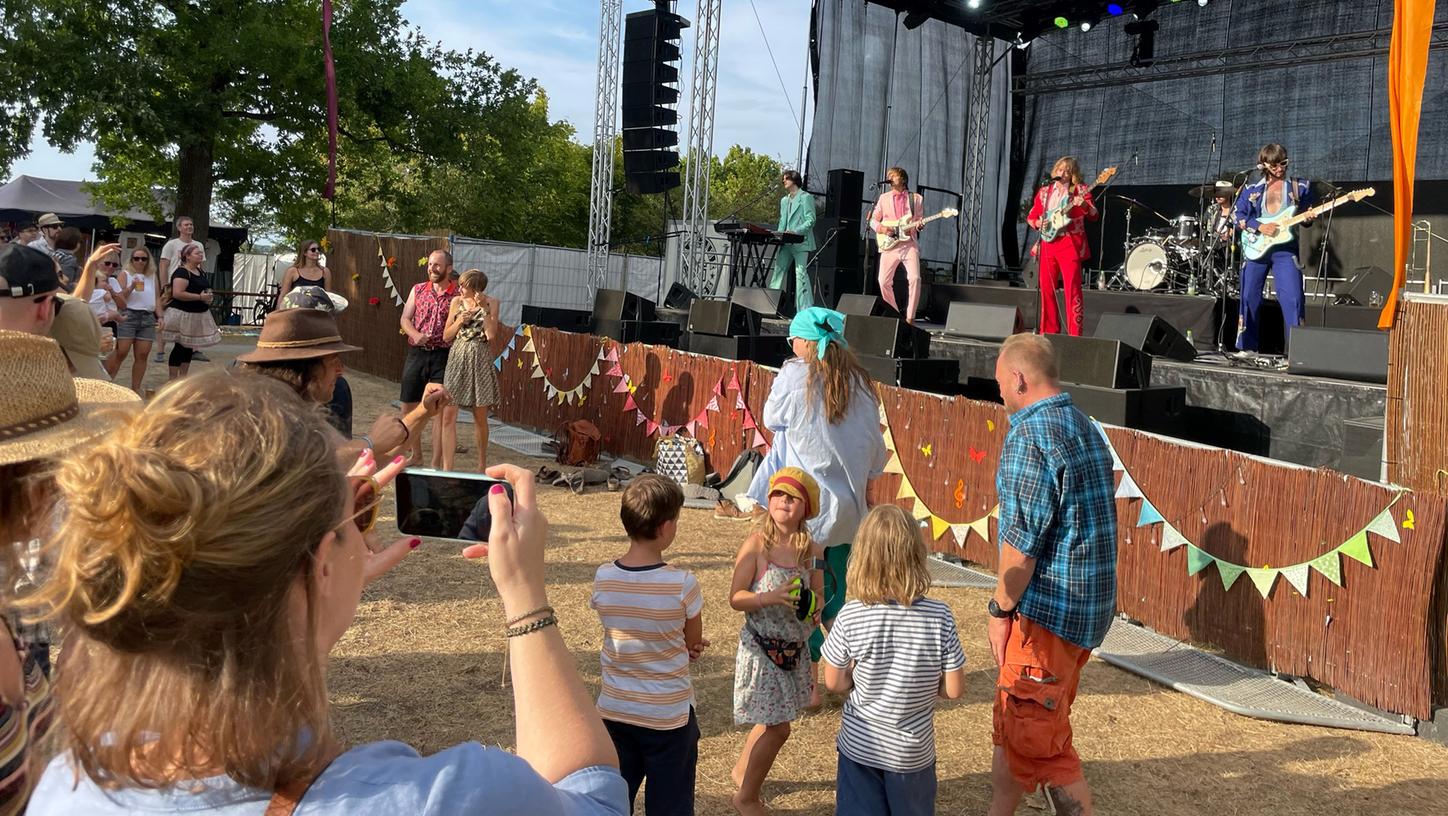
[133,334,1448,816]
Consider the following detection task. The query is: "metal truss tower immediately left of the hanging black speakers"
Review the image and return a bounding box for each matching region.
[588,0,624,292]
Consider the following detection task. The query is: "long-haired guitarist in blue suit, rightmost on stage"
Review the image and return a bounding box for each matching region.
[1237,142,1316,353]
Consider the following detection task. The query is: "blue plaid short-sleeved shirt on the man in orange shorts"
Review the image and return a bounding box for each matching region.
[996,394,1116,648]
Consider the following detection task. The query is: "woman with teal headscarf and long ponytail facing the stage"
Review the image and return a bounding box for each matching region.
[721,307,888,706]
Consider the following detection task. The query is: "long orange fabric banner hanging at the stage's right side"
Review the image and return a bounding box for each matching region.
[1377,0,1435,328]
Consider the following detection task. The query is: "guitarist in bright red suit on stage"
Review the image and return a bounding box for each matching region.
[1025,156,1099,337]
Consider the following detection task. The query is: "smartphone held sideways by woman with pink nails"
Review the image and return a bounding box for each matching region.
[392,467,513,541]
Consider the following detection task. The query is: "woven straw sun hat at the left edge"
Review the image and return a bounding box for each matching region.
[0,331,140,464]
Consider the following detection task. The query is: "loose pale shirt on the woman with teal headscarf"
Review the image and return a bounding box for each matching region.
[747,359,889,547]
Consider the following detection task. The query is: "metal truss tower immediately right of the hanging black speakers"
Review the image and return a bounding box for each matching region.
[679,0,724,295]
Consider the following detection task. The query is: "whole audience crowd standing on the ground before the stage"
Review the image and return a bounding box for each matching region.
[0,218,1115,816]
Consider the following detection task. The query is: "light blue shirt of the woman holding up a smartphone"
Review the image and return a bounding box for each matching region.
[28,741,628,816]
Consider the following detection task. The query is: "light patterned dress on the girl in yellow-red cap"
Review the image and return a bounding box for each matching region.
[734,561,814,725]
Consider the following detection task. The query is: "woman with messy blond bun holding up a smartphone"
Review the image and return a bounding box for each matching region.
[19,370,628,816]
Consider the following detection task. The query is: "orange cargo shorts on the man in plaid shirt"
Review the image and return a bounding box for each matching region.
[990,618,1090,790]
